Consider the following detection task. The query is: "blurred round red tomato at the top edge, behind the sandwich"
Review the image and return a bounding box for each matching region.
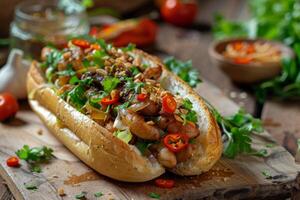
[160,0,198,26]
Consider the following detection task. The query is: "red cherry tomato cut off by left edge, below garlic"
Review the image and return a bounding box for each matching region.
[0,93,19,121]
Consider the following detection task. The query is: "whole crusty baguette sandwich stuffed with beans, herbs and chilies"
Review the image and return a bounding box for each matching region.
[27,39,222,182]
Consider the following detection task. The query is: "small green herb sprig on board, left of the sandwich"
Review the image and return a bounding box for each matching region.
[16,145,53,173]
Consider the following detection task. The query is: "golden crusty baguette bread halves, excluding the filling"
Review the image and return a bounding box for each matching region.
[27,50,222,182]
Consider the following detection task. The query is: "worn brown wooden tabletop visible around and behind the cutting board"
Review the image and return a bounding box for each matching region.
[0,0,300,200]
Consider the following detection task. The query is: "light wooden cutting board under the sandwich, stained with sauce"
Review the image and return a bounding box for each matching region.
[0,83,300,200]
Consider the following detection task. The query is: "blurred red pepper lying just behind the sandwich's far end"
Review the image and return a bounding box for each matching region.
[111,19,157,47]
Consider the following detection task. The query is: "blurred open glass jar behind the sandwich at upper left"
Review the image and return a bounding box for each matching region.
[10,0,89,59]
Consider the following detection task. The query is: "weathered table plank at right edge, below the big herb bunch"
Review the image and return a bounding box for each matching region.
[262,101,300,161]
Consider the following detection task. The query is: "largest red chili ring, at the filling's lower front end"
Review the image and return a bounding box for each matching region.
[164,133,189,153]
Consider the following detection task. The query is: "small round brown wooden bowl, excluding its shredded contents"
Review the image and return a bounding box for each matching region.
[209,38,294,84]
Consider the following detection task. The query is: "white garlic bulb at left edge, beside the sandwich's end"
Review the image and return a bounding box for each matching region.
[0,49,30,99]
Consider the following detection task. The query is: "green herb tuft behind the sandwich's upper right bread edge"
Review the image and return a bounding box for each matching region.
[164,57,201,87]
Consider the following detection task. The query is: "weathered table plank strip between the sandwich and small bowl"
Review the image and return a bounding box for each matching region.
[157,24,256,114]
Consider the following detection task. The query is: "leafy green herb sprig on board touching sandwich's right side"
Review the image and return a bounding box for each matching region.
[207,102,267,158]
